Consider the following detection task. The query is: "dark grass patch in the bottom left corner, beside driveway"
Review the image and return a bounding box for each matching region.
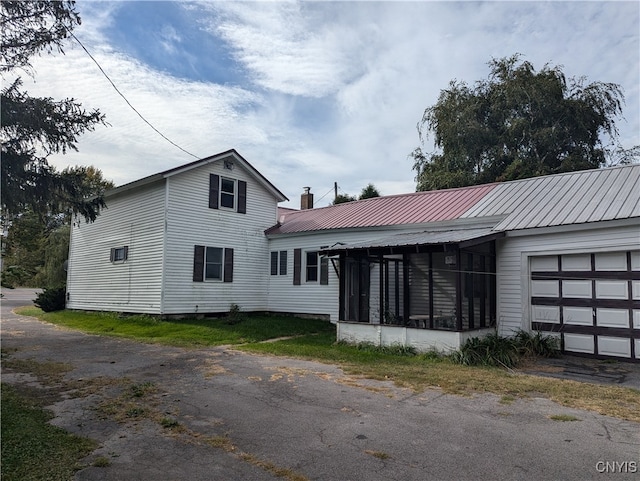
[2,383,97,481]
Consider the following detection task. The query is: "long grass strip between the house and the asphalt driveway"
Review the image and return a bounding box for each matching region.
[10,308,640,422]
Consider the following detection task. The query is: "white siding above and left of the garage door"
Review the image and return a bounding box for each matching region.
[497,221,640,334]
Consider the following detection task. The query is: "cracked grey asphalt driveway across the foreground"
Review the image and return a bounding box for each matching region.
[2,290,640,481]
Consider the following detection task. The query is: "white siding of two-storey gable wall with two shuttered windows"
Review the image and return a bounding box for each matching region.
[163,162,277,314]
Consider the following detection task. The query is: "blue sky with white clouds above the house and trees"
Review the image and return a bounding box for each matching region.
[15,0,640,208]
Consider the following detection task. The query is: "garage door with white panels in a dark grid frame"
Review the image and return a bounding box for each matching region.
[529,251,640,361]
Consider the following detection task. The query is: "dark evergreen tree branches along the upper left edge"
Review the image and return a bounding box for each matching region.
[0,0,104,221]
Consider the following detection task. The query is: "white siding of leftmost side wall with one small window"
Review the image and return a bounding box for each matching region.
[67,183,164,314]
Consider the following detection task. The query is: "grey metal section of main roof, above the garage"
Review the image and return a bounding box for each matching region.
[461,165,640,230]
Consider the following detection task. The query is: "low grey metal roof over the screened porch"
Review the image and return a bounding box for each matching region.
[322,227,505,255]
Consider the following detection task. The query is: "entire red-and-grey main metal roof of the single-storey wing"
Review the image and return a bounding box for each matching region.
[266,164,640,235]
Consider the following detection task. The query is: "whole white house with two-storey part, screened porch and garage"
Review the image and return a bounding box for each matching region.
[67,150,640,360]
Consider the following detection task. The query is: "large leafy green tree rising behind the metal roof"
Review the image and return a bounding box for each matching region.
[412,54,624,191]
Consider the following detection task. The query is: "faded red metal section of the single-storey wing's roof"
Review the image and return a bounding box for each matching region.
[267,184,497,235]
